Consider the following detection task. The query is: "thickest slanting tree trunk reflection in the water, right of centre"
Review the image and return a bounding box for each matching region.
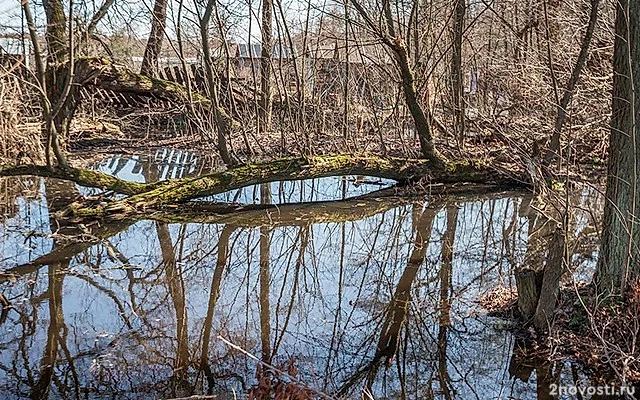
[337,204,439,397]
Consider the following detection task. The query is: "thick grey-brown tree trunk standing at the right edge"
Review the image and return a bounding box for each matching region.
[594,0,640,295]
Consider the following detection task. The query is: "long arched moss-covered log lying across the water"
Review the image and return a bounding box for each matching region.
[73,154,513,217]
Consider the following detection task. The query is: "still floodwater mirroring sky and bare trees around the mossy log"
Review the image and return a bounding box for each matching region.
[0,152,601,400]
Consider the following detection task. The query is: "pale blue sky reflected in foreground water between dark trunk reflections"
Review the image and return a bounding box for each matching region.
[0,180,604,399]
